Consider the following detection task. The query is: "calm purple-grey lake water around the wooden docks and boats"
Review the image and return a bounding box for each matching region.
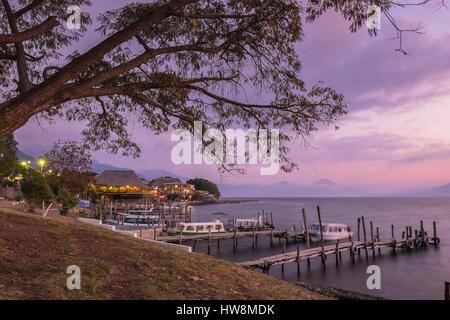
[189,198,450,299]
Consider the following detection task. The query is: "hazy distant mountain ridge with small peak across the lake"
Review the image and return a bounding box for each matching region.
[219,179,371,197]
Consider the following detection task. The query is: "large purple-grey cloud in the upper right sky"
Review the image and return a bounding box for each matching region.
[298,13,450,110]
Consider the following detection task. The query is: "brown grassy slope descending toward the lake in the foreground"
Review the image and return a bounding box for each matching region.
[0,209,321,299]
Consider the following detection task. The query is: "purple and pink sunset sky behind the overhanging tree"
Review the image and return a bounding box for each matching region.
[16,1,450,191]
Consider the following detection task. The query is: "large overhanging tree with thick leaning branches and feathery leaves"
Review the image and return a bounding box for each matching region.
[0,0,436,171]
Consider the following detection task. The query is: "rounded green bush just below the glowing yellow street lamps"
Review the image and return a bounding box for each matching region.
[20,169,55,215]
